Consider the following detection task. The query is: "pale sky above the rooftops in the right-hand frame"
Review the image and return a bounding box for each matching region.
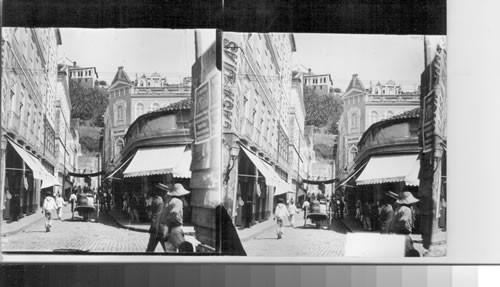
[294,33,424,91]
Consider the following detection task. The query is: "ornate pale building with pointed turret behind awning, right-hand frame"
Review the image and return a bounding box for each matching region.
[336,74,420,179]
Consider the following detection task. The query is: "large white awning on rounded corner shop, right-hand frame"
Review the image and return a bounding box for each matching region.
[356,154,420,186]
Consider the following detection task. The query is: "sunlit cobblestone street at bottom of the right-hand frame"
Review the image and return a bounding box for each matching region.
[242,213,346,257]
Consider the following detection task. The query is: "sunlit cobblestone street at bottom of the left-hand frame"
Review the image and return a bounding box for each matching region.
[1,207,163,252]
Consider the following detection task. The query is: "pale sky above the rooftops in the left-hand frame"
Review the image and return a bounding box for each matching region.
[58,28,195,84]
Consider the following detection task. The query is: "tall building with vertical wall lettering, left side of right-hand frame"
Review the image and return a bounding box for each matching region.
[222,33,296,230]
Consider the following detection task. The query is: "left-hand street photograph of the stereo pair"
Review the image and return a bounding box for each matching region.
[0,27,227,262]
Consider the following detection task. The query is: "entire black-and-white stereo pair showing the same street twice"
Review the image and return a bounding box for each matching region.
[0,28,447,262]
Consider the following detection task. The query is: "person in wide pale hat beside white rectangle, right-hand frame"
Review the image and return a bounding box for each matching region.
[389,191,419,235]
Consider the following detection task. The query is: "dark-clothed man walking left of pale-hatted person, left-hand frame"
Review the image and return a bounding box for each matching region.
[146,185,168,252]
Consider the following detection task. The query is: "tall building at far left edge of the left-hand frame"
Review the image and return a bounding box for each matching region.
[0,28,61,222]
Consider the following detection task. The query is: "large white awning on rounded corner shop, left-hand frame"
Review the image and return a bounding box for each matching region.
[123,146,191,177]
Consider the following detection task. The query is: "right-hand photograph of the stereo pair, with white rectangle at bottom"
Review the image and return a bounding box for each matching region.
[222,33,447,257]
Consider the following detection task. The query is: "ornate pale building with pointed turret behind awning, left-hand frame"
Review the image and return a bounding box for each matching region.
[103,67,191,173]
